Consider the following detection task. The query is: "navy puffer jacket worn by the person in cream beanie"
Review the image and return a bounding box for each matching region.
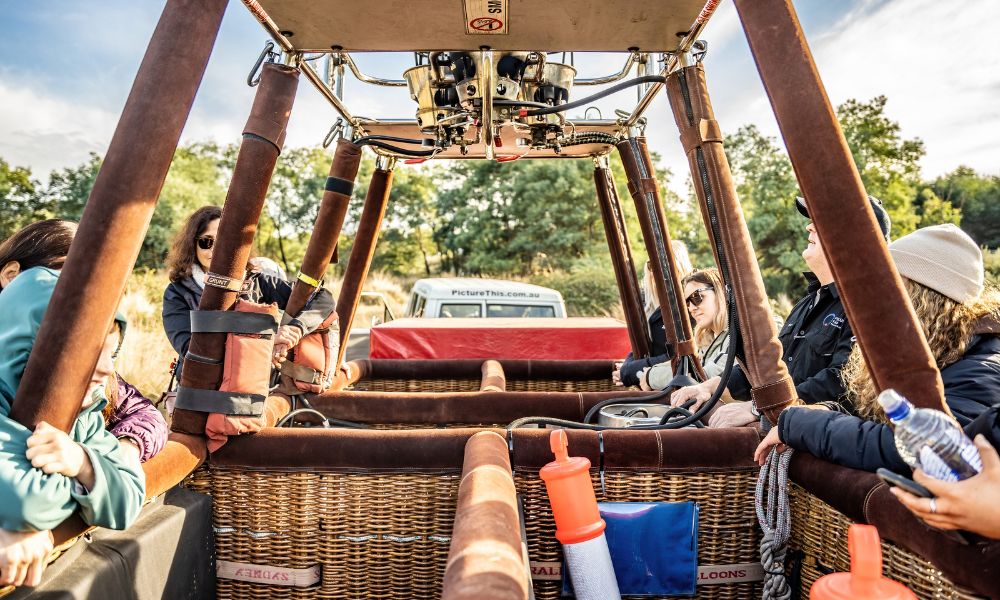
[778,334,1000,473]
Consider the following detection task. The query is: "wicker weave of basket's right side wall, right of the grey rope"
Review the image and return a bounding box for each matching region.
[790,484,979,600]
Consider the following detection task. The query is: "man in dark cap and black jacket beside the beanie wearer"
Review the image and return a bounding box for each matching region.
[670,196,891,427]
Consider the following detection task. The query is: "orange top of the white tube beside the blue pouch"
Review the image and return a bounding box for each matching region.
[539,429,604,544]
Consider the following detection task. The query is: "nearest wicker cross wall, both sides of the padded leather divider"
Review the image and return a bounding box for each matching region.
[186,466,760,599]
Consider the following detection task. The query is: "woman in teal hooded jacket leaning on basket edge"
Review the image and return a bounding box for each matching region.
[0,267,146,579]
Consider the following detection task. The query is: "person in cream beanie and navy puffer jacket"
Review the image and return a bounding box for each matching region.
[755,224,1000,473]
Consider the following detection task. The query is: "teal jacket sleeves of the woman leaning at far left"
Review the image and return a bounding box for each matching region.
[0,411,145,531]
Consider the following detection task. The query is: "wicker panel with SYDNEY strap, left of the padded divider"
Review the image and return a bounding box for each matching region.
[187,467,460,600]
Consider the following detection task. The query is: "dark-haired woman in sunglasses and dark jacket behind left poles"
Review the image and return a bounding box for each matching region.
[163,206,336,376]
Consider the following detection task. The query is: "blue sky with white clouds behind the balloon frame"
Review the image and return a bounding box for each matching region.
[0,0,1000,192]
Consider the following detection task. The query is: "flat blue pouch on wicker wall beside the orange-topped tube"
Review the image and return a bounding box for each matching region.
[563,502,698,596]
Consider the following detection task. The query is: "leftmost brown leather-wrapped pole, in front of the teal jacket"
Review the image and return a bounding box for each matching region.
[10,0,226,431]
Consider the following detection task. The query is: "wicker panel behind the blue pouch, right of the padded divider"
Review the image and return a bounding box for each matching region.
[514,470,761,600]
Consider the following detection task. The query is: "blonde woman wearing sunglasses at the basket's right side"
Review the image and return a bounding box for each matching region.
[639,268,729,390]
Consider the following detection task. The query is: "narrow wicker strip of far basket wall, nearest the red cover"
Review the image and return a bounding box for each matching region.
[351,380,623,393]
